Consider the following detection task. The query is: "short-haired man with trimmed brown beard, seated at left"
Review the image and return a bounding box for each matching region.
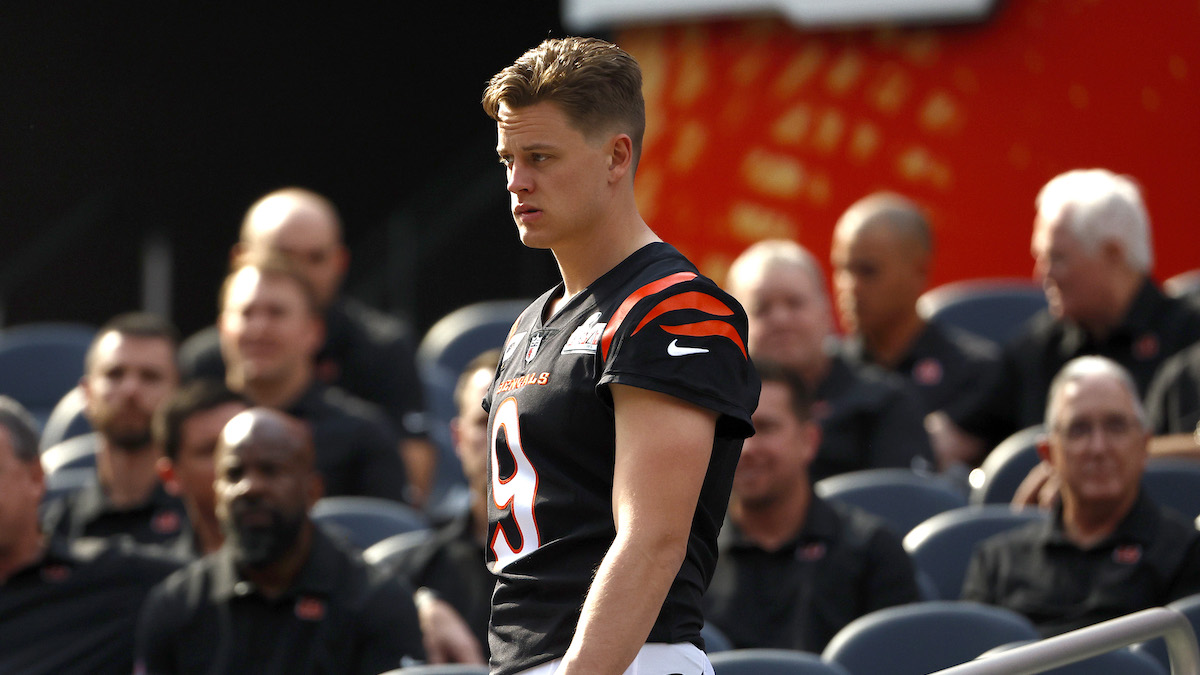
[42,312,186,544]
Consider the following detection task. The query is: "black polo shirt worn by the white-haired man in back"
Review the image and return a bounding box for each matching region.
[950,279,1200,447]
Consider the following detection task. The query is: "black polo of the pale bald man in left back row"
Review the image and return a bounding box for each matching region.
[179,298,427,437]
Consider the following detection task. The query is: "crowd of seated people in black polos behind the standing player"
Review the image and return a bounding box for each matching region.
[7,169,1200,673]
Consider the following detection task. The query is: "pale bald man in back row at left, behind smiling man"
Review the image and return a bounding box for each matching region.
[180,187,436,503]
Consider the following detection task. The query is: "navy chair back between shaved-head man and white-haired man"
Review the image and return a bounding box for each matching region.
[917,279,1046,344]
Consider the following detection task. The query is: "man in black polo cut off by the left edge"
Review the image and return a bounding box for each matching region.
[0,396,179,675]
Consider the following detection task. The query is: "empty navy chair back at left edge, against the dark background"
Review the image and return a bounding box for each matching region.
[0,323,96,426]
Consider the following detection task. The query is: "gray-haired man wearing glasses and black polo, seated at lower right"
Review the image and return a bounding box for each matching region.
[962,357,1200,635]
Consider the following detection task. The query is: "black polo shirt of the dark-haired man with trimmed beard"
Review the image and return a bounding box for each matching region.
[42,470,187,545]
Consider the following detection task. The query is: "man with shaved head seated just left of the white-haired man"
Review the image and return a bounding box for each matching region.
[830,192,1000,470]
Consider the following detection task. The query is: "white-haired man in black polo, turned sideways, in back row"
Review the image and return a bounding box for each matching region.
[938,169,1200,456]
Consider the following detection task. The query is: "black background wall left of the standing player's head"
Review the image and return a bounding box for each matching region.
[0,0,563,334]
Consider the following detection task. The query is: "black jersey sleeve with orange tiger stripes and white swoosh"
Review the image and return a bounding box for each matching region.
[598,273,760,437]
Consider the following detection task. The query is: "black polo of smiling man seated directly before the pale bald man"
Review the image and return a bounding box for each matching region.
[287,382,408,501]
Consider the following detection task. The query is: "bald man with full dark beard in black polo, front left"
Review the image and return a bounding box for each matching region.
[137,408,424,675]
